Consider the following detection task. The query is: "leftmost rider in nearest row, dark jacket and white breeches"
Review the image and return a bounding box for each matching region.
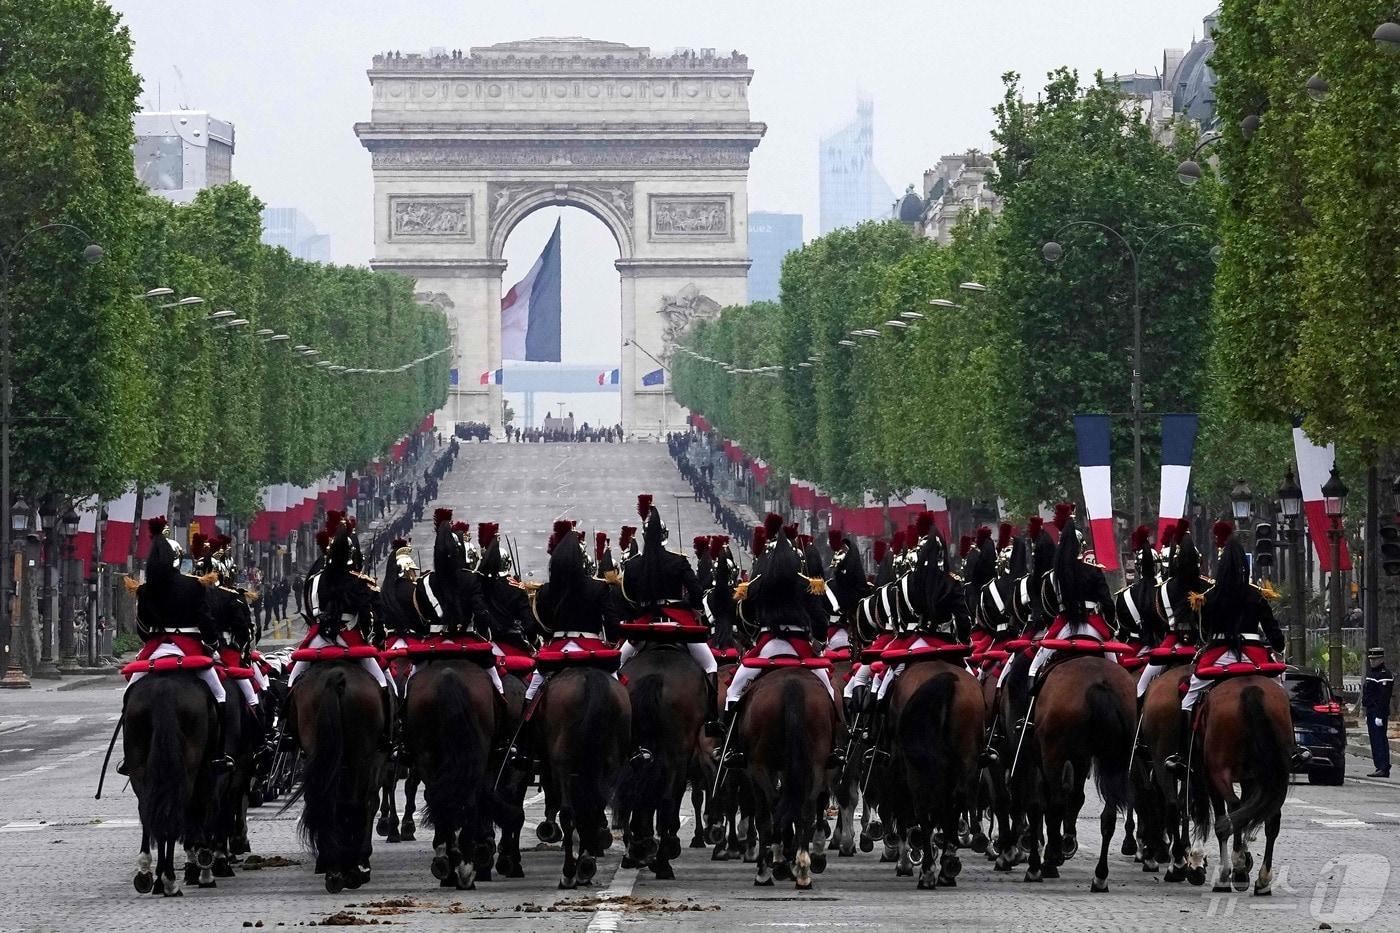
[116,516,238,776]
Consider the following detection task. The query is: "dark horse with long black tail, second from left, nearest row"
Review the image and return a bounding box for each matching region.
[288,661,388,894]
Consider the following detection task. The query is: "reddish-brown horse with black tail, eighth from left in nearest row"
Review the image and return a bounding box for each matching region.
[1019,656,1137,892]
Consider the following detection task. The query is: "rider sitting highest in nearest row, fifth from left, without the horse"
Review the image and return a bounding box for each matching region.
[617,493,720,717]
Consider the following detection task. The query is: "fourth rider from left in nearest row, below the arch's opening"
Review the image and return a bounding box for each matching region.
[525,520,617,700]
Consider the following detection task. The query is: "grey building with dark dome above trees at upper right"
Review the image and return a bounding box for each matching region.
[1112,8,1219,138]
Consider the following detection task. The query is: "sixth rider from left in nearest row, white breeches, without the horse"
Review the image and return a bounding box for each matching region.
[721,523,836,731]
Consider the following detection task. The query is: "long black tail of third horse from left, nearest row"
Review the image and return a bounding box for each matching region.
[423,667,486,829]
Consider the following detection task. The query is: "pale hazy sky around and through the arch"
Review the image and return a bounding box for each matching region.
[111,0,1214,395]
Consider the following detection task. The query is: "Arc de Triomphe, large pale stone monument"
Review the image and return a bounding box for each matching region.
[354,39,766,434]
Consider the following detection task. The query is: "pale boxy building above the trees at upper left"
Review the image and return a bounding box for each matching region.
[132,111,234,205]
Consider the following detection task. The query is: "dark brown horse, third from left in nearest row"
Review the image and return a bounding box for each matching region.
[405,656,497,891]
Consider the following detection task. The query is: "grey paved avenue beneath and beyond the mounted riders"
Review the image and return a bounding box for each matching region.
[0,445,1400,933]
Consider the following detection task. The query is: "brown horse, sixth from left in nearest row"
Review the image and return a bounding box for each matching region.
[735,668,839,890]
